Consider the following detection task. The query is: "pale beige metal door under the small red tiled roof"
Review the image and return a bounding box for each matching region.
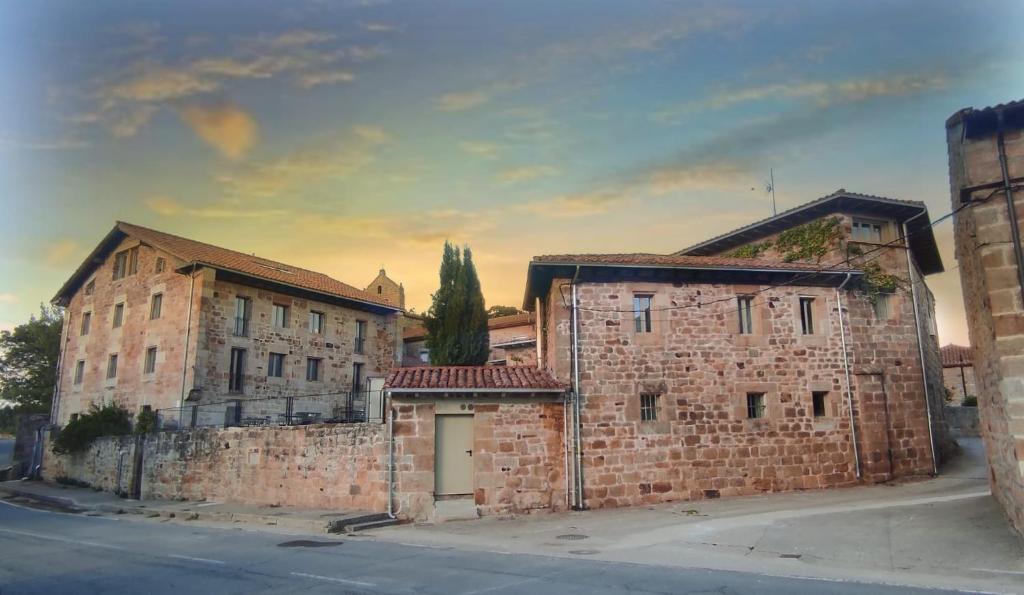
[434,415,473,496]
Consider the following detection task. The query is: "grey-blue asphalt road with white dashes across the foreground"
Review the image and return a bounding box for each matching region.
[0,501,962,595]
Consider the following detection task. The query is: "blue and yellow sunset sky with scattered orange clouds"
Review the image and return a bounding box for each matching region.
[0,0,1024,343]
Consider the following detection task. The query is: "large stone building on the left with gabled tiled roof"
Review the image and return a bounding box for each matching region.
[52,222,400,424]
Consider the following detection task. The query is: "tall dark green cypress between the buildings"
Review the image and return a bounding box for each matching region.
[424,242,490,366]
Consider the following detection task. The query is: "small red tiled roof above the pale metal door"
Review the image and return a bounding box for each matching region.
[384,366,567,392]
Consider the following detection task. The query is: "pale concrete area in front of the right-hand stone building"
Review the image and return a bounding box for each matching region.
[364,439,1024,593]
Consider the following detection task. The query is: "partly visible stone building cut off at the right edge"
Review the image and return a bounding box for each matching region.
[946,100,1024,533]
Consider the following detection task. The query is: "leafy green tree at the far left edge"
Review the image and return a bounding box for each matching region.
[0,305,63,413]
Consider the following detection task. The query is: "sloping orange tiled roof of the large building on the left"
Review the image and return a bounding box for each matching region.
[55,221,395,309]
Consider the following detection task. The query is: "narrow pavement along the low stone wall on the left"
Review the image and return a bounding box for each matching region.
[0,480,386,533]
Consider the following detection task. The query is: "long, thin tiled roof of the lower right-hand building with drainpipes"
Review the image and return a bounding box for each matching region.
[534,253,854,272]
